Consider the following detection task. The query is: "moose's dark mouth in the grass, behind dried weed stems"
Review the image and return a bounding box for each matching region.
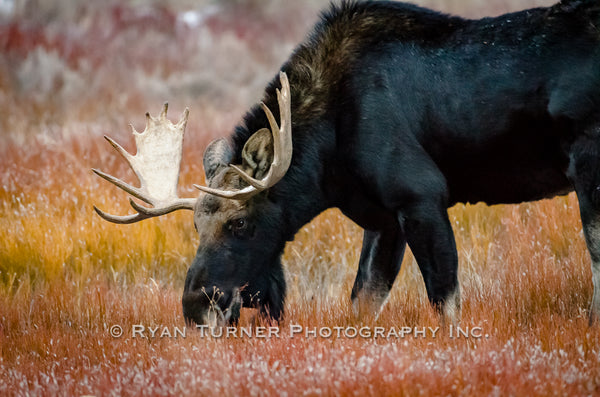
[182,288,243,328]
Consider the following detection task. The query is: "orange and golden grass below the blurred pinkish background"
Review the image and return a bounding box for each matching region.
[0,120,600,395]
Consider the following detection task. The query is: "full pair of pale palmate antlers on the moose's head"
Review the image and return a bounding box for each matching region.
[92,72,292,224]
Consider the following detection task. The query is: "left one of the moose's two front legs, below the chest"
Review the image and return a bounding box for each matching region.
[352,224,406,316]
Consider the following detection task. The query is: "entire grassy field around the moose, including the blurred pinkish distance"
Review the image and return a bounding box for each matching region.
[0,0,600,396]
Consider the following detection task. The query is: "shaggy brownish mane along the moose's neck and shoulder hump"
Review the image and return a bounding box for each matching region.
[283,2,463,123]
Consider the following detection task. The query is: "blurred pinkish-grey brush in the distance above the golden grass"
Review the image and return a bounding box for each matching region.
[0,0,553,145]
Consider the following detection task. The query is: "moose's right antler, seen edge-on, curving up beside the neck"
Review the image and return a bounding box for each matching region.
[194,72,293,200]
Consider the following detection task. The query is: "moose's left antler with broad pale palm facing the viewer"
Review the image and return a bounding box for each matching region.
[92,103,197,224]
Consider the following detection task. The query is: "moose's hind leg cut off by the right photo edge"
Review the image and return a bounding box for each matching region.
[568,134,600,325]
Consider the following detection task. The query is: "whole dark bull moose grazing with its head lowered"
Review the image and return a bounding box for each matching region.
[94,0,600,324]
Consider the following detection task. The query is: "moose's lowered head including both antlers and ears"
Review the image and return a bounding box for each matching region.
[93,72,292,325]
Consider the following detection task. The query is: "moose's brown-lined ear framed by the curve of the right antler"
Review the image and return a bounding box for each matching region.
[241,128,273,179]
